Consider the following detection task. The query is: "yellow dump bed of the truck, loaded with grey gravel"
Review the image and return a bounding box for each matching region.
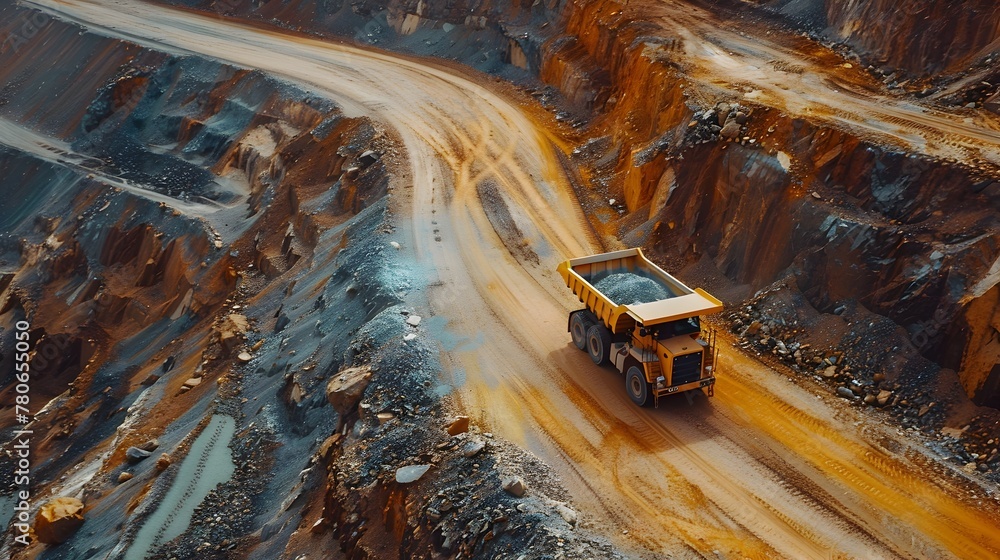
[557,249,722,333]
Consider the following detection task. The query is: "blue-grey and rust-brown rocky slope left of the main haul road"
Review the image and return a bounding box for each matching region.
[0,3,616,559]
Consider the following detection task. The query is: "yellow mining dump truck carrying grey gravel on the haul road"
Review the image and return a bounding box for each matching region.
[557,249,722,406]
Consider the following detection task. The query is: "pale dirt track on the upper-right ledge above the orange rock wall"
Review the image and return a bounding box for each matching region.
[629,1,1000,173]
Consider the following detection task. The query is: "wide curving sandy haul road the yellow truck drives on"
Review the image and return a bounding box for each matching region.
[21,0,1000,558]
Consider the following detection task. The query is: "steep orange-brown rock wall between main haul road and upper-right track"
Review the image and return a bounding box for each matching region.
[542,0,1000,418]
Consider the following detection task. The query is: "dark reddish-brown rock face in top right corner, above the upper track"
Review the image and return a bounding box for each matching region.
[826,0,1000,74]
